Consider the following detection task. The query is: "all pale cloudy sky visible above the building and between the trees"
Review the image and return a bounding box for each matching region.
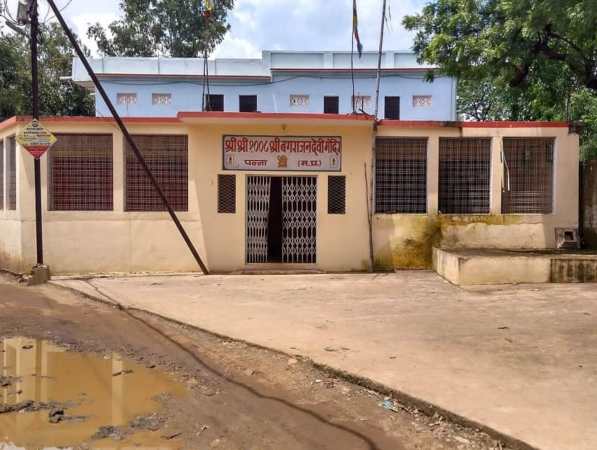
[9,0,426,58]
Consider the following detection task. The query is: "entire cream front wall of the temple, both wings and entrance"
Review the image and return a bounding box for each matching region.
[0,121,578,273]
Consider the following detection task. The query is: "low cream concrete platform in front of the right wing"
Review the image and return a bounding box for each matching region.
[433,248,597,286]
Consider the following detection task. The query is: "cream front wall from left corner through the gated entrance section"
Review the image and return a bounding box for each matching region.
[0,122,371,274]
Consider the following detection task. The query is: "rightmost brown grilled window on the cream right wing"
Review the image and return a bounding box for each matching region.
[502,138,554,214]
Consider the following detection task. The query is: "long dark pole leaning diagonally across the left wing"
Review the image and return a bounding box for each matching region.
[46,0,209,275]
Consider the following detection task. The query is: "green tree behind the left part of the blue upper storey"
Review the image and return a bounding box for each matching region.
[87,0,234,58]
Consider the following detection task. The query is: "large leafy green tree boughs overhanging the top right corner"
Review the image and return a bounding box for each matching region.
[404,0,597,91]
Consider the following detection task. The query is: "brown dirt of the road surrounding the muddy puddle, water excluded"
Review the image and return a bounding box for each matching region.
[0,277,505,450]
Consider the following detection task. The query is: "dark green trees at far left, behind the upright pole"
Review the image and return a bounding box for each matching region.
[0,23,94,120]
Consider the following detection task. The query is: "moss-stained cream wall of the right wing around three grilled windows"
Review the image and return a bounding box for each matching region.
[374,126,579,269]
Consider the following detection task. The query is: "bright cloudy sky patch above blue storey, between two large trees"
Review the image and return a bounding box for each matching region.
[211,0,424,56]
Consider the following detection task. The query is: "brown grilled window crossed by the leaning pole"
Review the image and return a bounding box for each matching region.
[125,135,188,211]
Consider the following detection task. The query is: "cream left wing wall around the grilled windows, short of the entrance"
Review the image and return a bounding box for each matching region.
[10,121,204,274]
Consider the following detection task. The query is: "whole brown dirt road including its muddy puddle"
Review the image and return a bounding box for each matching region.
[0,274,502,450]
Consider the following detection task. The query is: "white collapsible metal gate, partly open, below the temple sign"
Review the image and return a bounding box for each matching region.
[247,176,317,264]
